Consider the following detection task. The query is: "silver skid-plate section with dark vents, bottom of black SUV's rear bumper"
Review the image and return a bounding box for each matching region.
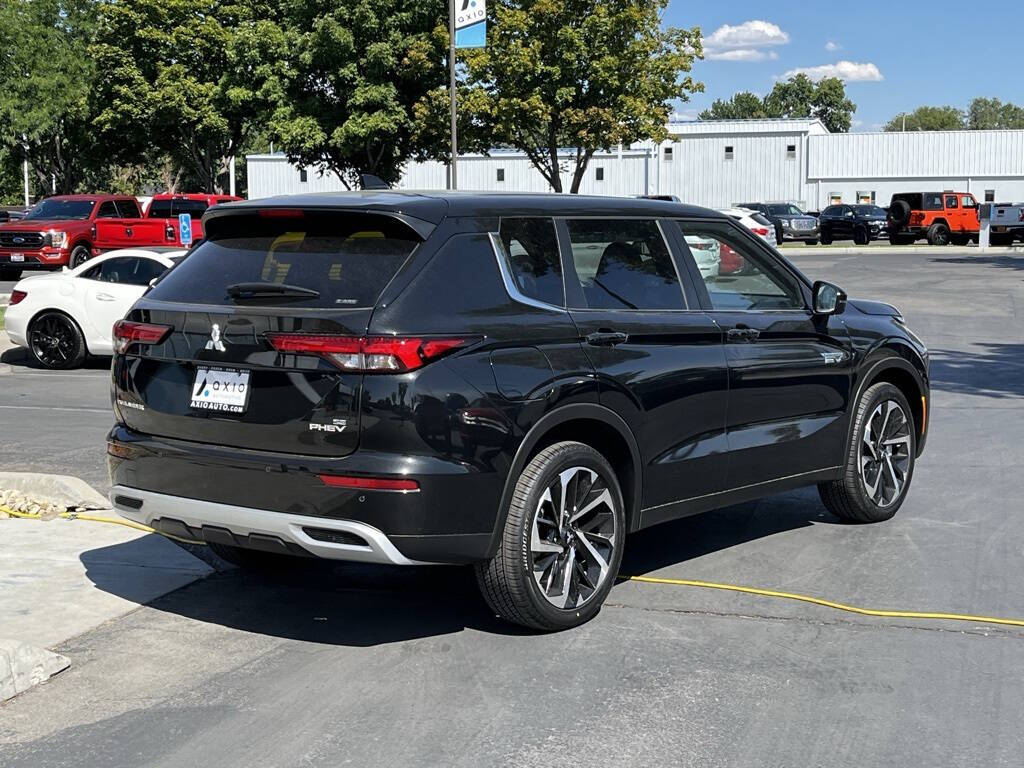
[111,485,432,565]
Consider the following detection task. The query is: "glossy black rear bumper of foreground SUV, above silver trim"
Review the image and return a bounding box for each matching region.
[108,426,504,563]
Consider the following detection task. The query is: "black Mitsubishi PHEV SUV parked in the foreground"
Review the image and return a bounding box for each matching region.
[108,191,929,630]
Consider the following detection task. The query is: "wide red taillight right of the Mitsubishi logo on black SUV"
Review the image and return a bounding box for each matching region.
[266,334,470,374]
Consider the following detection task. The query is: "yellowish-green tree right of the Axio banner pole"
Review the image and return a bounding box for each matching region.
[465,0,703,193]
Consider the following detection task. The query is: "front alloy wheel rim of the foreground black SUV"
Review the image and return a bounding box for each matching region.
[860,400,912,508]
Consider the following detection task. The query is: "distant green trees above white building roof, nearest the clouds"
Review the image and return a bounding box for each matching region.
[700,74,857,133]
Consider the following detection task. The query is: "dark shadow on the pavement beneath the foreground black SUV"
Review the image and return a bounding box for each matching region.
[81,489,836,647]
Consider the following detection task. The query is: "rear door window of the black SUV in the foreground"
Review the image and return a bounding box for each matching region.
[566,219,686,309]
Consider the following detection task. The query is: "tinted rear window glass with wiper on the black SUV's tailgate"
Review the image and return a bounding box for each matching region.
[148,212,420,308]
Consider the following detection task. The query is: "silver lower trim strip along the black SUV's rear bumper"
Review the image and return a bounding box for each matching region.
[111,485,427,565]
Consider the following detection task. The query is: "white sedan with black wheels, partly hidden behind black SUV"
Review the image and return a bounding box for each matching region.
[4,248,185,369]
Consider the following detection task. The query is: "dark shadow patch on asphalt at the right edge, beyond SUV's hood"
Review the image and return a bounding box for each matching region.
[930,344,1024,397]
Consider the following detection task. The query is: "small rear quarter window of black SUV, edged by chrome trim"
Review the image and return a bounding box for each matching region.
[498,218,565,306]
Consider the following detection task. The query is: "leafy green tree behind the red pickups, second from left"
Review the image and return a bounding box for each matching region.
[90,0,283,193]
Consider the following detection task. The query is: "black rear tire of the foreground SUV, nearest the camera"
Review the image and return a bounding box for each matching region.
[476,442,626,631]
